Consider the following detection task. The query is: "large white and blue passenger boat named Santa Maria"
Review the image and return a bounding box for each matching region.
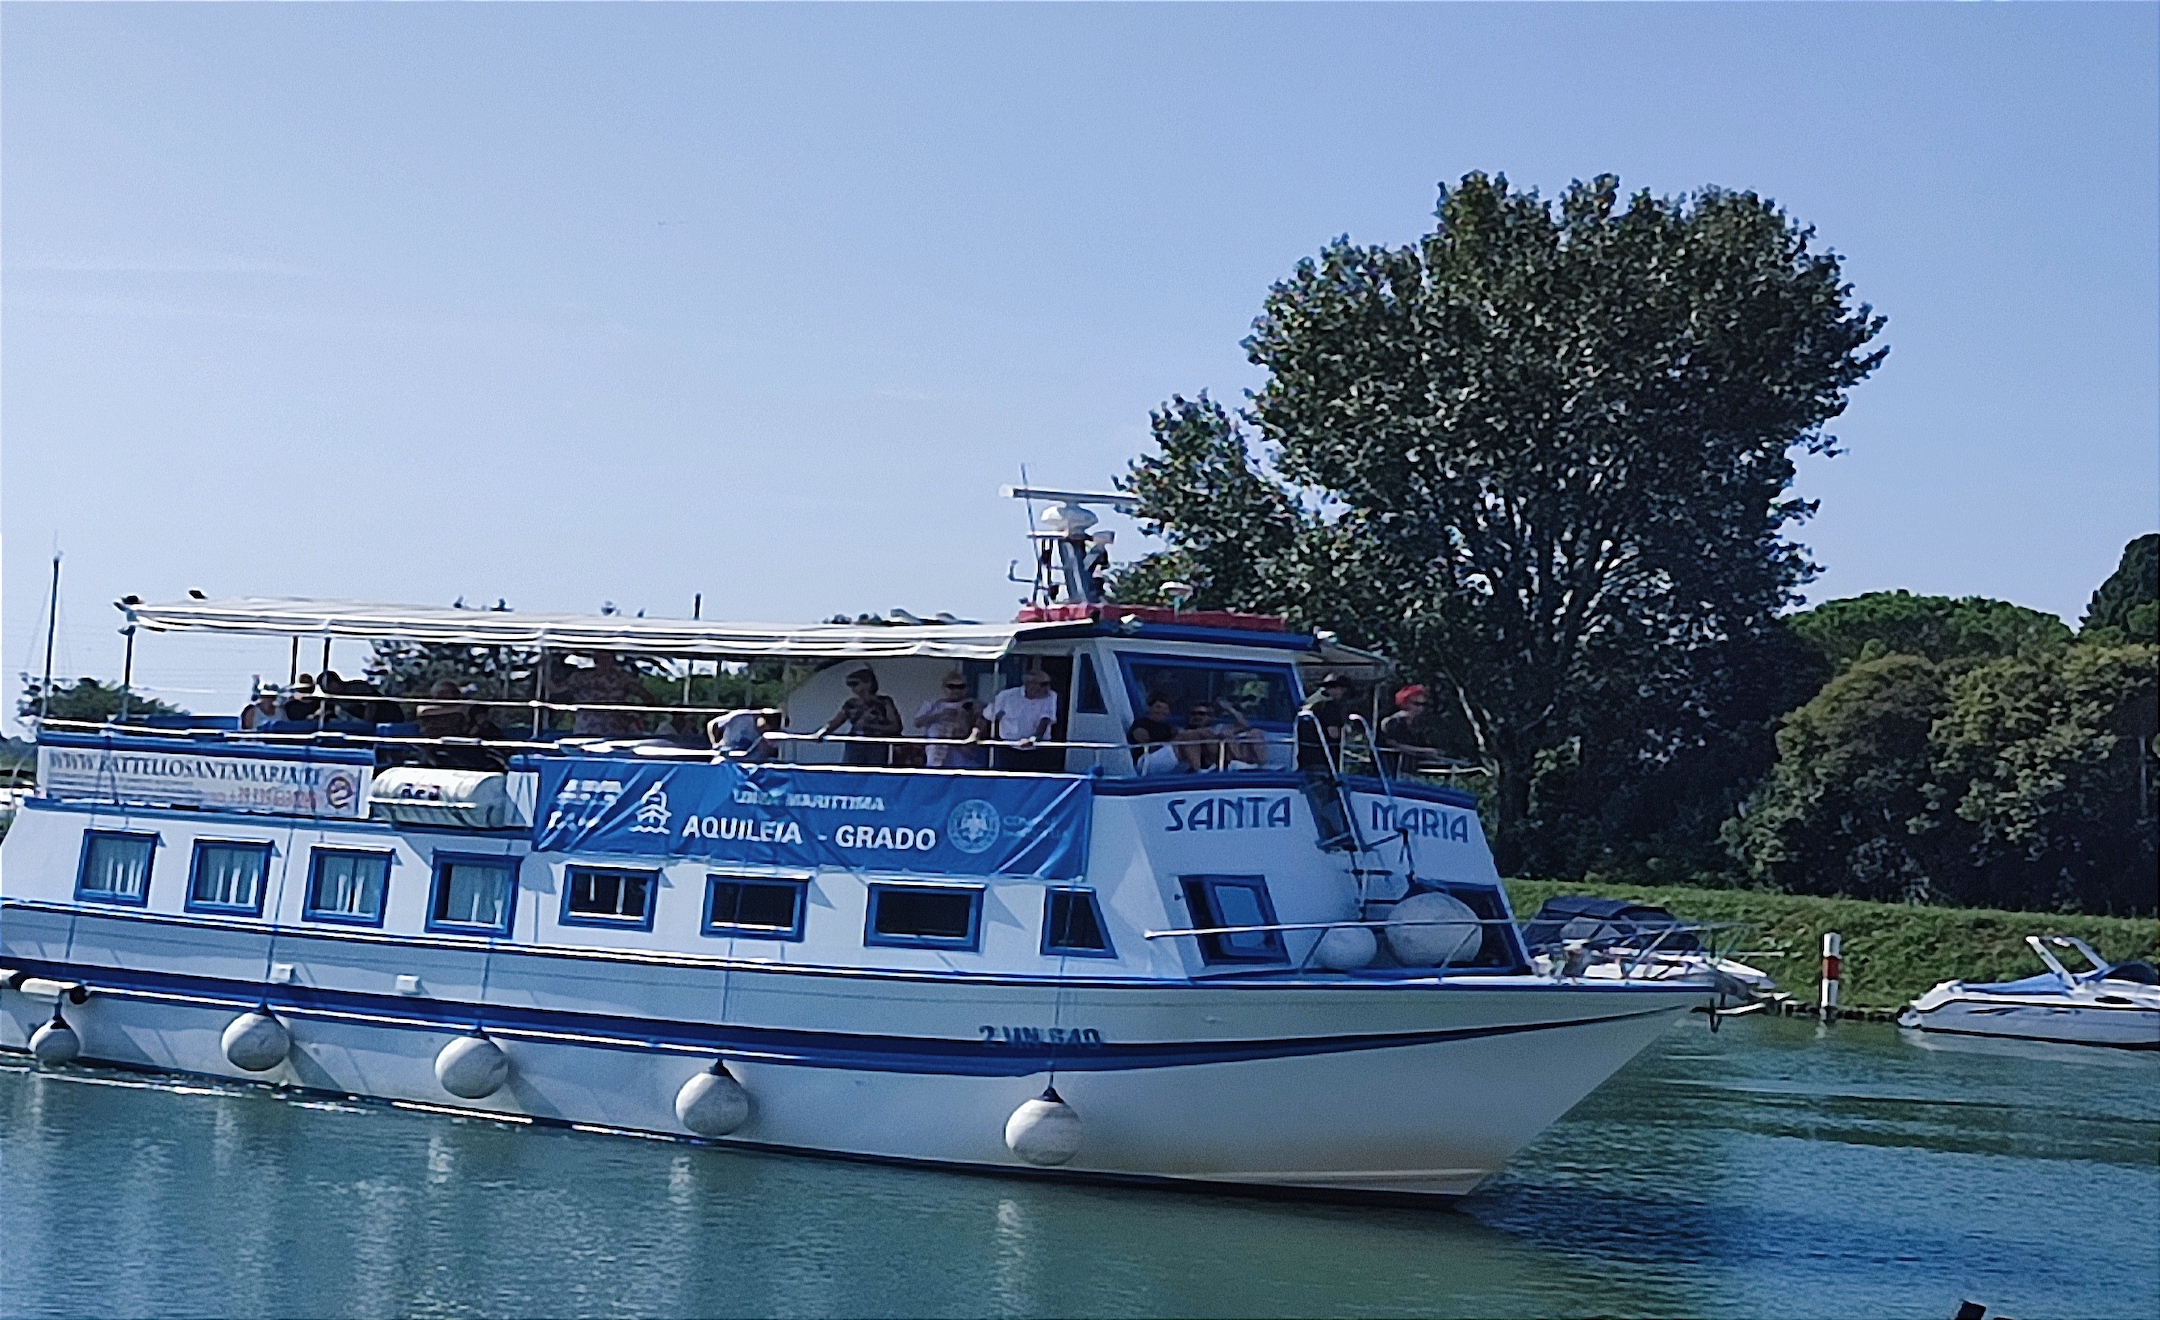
[0,493,1715,1199]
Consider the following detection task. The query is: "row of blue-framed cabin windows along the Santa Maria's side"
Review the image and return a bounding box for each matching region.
[76,830,1131,961]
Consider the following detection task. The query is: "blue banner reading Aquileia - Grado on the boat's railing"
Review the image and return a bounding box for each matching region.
[534,758,1093,879]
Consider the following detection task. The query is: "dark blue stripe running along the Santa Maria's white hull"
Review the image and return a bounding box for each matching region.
[11,959,1672,1078]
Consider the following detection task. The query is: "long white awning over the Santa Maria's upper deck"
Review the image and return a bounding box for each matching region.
[121,596,1378,665]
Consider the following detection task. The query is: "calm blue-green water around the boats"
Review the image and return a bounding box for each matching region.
[0,1018,2160,1320]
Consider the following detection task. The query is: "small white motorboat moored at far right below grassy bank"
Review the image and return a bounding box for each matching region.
[1896,935,2160,1050]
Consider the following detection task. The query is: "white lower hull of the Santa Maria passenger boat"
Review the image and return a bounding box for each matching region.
[0,910,1709,1197]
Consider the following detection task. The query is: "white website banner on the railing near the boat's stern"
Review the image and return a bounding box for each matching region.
[37,747,374,819]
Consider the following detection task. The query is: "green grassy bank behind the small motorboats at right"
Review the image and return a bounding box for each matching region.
[1508,879,2160,1009]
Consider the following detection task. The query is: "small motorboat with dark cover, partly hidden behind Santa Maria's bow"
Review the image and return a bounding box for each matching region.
[1523,894,1780,1002]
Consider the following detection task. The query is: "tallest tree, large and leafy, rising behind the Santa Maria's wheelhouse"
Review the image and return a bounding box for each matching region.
[1128,173,1881,866]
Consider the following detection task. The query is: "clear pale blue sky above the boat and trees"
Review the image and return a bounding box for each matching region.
[0,4,2160,711]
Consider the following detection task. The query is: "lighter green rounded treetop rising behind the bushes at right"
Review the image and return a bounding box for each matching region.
[1791,592,2069,668]
